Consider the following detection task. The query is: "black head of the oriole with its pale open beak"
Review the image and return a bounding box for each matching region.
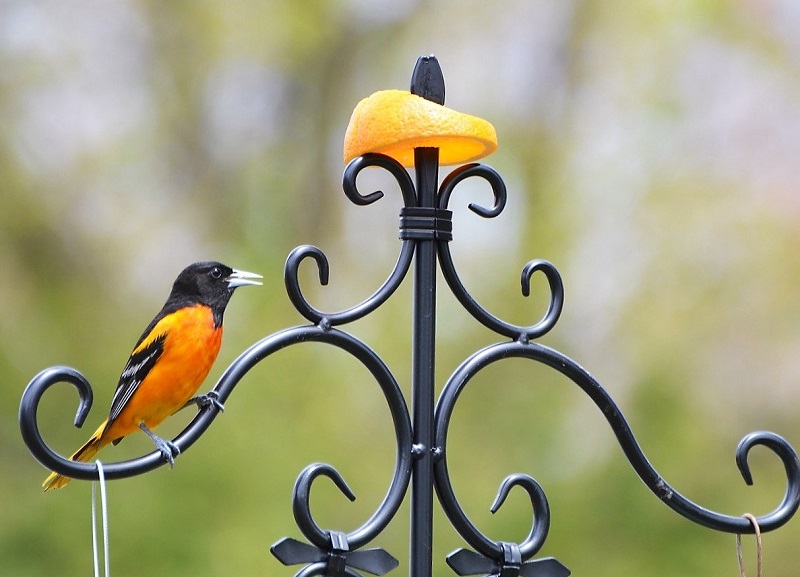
[165,261,261,325]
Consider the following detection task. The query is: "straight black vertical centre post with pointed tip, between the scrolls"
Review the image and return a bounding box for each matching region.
[410,57,444,577]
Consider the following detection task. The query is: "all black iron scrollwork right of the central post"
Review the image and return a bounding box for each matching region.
[434,152,800,577]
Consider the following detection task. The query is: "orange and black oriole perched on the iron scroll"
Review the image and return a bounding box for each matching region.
[42,261,263,491]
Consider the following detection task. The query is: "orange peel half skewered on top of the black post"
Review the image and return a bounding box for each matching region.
[344,90,497,166]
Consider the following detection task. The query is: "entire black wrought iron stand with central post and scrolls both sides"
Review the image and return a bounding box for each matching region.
[20,56,800,577]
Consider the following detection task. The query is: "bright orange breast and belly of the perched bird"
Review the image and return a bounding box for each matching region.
[104,305,222,439]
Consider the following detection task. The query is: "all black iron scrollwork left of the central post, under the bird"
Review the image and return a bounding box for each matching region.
[20,145,415,577]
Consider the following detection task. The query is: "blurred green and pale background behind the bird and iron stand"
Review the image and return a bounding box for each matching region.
[0,0,800,577]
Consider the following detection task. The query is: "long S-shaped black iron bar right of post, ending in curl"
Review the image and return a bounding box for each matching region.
[434,342,800,556]
